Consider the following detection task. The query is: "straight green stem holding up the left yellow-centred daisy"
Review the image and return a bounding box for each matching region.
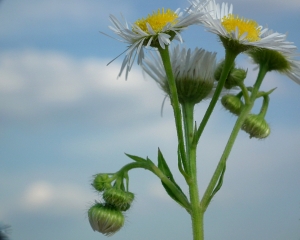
[158,45,188,171]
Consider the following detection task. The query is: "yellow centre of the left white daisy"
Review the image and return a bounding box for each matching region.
[133,8,178,34]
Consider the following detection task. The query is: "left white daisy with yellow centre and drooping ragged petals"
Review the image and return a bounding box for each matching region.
[105,8,204,78]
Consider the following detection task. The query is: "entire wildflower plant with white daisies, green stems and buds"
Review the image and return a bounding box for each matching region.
[88,0,300,240]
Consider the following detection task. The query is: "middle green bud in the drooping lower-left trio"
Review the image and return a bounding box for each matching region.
[102,188,134,211]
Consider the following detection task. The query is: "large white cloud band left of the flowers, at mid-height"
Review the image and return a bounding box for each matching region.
[0,50,163,121]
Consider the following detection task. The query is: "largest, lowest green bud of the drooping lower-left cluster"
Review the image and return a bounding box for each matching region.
[88,203,125,236]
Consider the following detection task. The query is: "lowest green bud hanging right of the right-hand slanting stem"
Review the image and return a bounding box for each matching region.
[242,114,271,139]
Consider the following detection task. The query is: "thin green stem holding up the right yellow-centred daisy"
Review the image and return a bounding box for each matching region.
[193,49,239,145]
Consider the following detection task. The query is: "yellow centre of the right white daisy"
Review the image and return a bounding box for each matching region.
[222,14,260,42]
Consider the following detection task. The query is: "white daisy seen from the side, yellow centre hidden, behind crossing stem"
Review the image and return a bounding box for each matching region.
[142,46,216,104]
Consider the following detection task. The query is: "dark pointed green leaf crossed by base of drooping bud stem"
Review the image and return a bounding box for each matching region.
[158,149,188,208]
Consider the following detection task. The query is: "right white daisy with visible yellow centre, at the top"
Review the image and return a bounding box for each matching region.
[190,0,296,52]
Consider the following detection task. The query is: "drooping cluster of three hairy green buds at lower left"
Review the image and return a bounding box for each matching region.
[88,174,134,236]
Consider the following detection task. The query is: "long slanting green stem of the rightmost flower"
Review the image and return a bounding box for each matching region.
[201,62,268,211]
